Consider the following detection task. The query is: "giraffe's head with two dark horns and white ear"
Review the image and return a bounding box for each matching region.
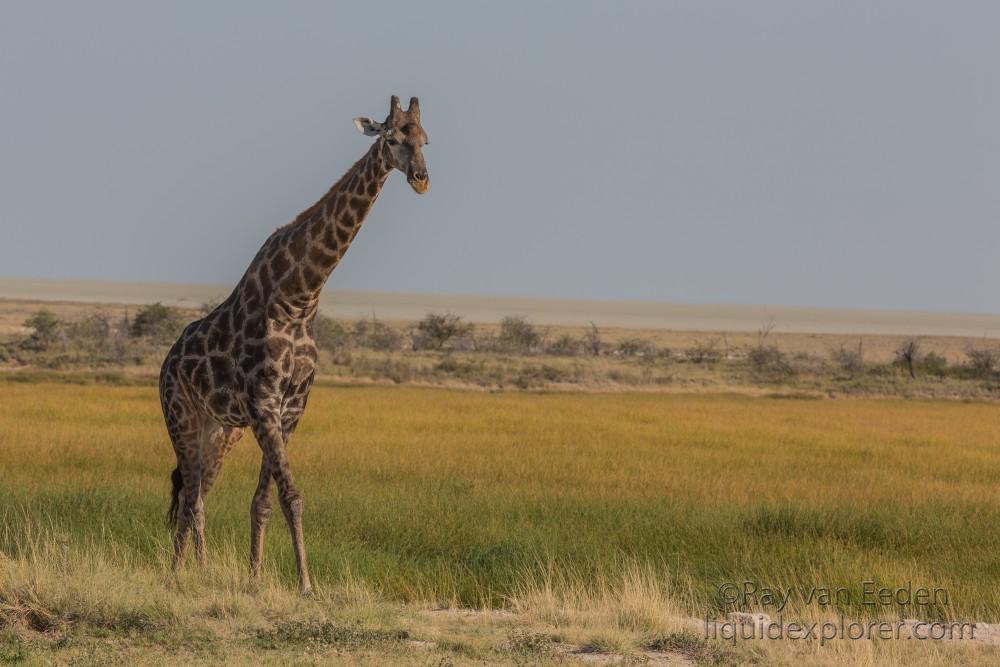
[354,95,430,195]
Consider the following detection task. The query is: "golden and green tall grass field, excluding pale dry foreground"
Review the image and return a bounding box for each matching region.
[0,384,1000,625]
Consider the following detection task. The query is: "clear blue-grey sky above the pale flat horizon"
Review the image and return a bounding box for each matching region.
[0,0,1000,312]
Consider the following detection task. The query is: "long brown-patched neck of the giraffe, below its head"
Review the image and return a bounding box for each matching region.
[259,139,392,308]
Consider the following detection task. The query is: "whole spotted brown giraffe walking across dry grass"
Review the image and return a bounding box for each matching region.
[160,95,430,594]
